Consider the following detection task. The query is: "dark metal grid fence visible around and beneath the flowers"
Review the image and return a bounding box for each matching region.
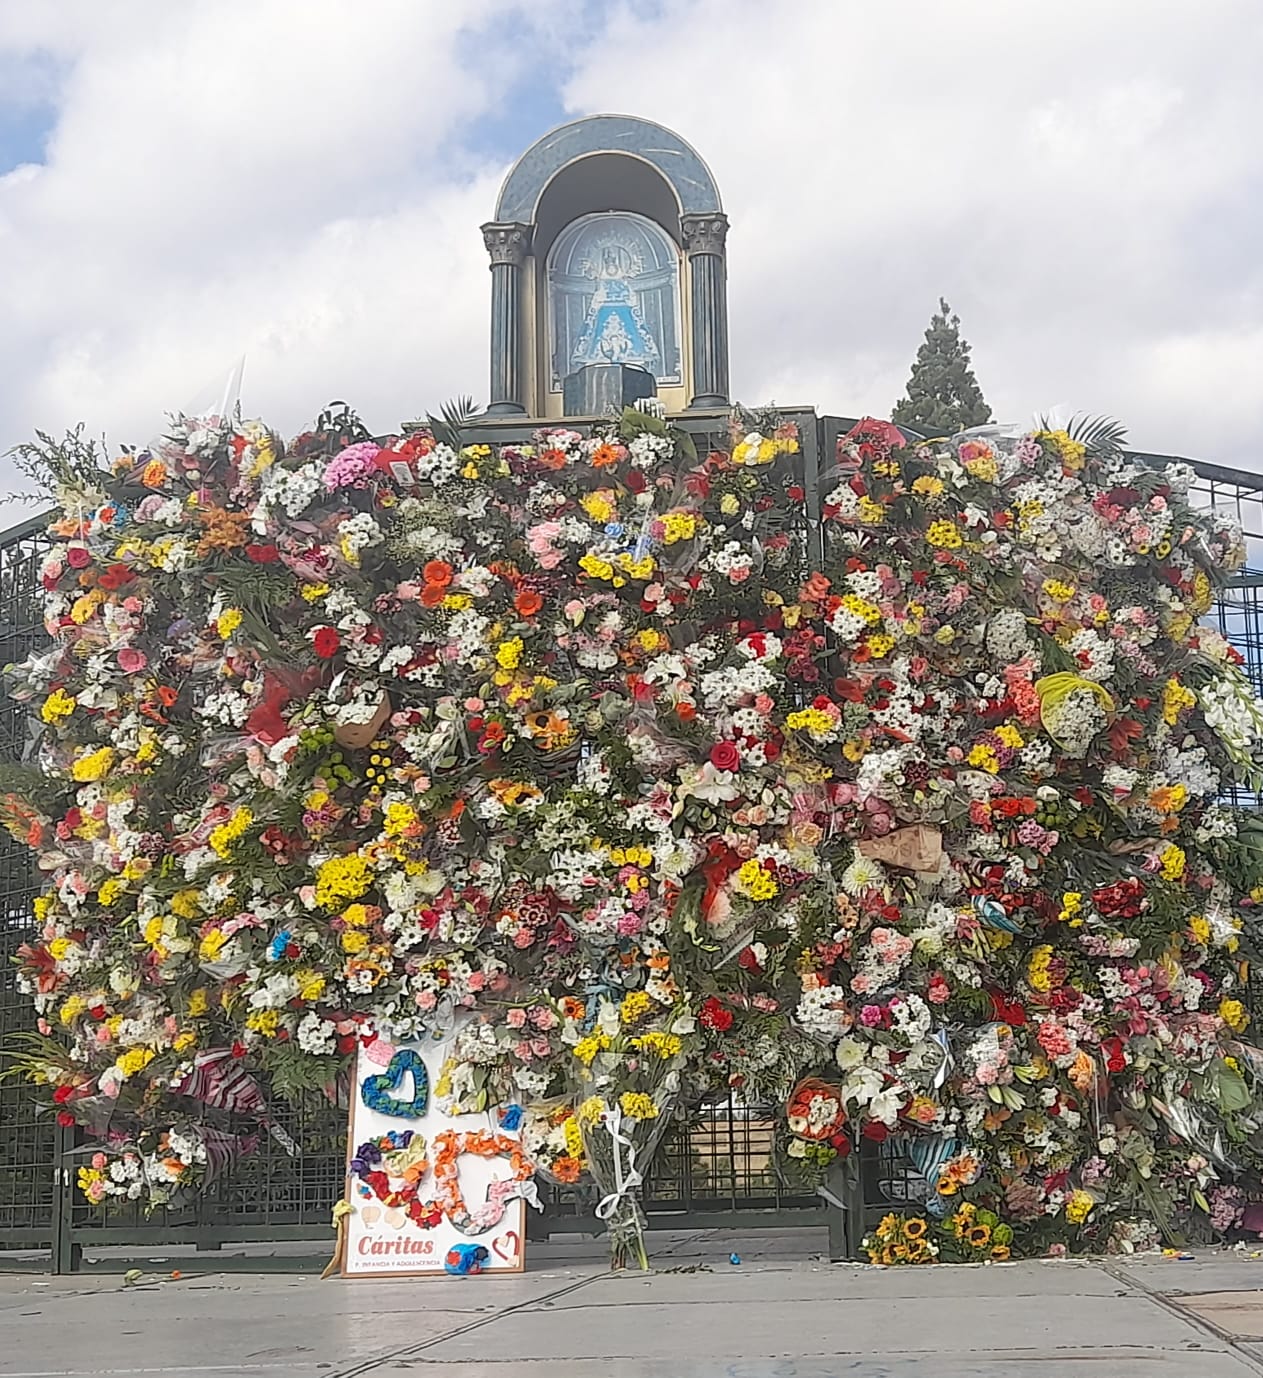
[0,411,1263,1271]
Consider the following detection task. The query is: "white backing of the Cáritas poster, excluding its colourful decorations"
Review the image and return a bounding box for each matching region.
[342,1039,526,1277]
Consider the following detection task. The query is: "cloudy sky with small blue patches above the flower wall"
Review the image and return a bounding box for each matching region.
[0,0,1263,496]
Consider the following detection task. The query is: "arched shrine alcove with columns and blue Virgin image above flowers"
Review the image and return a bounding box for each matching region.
[482,114,729,418]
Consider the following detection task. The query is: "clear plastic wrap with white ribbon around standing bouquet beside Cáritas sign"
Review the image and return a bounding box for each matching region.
[578,1096,675,1272]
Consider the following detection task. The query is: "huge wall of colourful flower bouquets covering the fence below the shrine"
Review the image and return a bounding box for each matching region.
[4,412,1263,1262]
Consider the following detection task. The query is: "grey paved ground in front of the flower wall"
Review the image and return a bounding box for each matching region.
[0,1231,1263,1378]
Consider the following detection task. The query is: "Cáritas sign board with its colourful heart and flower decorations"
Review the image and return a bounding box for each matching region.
[342,1039,529,1277]
